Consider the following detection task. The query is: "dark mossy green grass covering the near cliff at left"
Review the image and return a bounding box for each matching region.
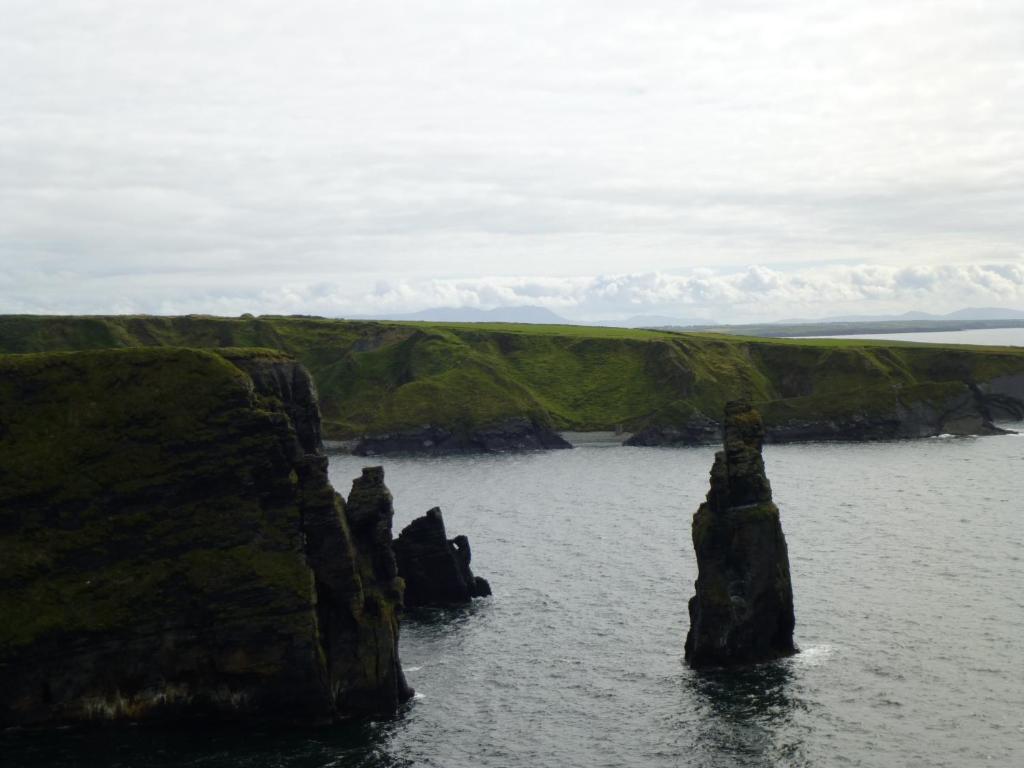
[0,348,313,655]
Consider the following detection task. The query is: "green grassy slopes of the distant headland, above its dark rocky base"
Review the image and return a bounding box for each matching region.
[0,315,1024,437]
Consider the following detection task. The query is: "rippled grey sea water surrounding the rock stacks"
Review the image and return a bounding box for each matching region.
[8,425,1024,768]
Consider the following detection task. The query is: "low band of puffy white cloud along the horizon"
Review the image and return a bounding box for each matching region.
[0,260,1024,323]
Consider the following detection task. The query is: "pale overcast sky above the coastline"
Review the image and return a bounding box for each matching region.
[0,0,1024,322]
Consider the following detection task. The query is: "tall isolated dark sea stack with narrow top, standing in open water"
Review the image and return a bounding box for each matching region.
[686,401,797,668]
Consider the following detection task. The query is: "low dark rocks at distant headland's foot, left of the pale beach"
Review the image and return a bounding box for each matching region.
[352,419,572,456]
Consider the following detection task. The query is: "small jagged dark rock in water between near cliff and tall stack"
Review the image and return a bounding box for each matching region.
[394,507,490,607]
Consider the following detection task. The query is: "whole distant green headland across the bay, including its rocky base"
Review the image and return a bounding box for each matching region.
[0,315,1024,456]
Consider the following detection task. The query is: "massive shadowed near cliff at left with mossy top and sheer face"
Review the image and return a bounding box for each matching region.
[0,349,411,725]
